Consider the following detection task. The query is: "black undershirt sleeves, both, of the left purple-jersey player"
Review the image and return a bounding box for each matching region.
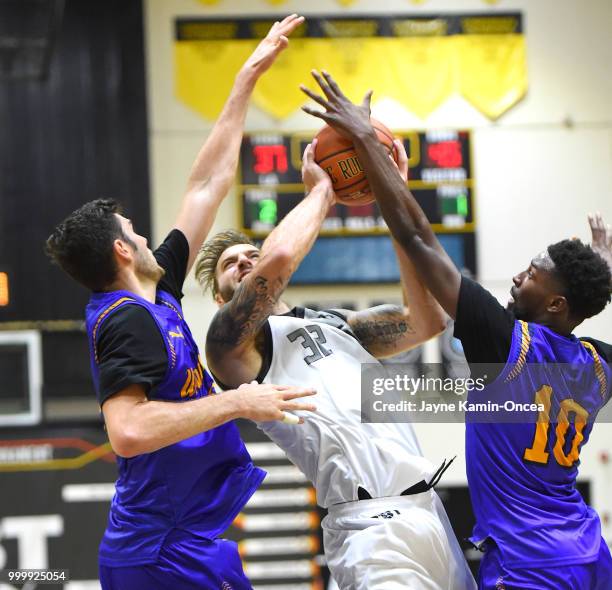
[93,229,189,405]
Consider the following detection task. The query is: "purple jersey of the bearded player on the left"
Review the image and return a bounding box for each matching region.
[86,290,265,566]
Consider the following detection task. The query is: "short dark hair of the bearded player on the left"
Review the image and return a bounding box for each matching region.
[45,199,133,291]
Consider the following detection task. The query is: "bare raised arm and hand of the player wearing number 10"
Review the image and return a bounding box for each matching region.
[302,72,461,318]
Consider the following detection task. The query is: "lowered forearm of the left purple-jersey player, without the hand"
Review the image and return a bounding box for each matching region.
[109,392,240,457]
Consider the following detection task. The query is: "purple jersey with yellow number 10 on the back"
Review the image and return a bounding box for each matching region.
[466,320,612,567]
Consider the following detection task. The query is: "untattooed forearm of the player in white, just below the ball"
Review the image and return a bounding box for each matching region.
[261,183,334,275]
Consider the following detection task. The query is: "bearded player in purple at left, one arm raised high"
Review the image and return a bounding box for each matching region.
[47,15,313,590]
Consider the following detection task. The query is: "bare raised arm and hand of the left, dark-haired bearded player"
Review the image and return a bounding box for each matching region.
[175,14,304,272]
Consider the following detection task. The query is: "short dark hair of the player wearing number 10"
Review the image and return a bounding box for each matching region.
[548,240,612,319]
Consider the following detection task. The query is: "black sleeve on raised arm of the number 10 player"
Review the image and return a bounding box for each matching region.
[455,277,515,363]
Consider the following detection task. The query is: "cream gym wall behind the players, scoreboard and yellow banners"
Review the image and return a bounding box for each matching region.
[145,0,612,542]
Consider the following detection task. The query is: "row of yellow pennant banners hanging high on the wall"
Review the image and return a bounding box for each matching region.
[175,17,527,119]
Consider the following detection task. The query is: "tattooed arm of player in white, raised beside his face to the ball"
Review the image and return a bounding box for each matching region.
[206,145,335,386]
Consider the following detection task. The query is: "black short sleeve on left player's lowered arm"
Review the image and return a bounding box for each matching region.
[97,305,168,406]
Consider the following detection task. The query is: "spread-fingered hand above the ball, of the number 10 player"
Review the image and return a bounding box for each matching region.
[300,70,372,138]
